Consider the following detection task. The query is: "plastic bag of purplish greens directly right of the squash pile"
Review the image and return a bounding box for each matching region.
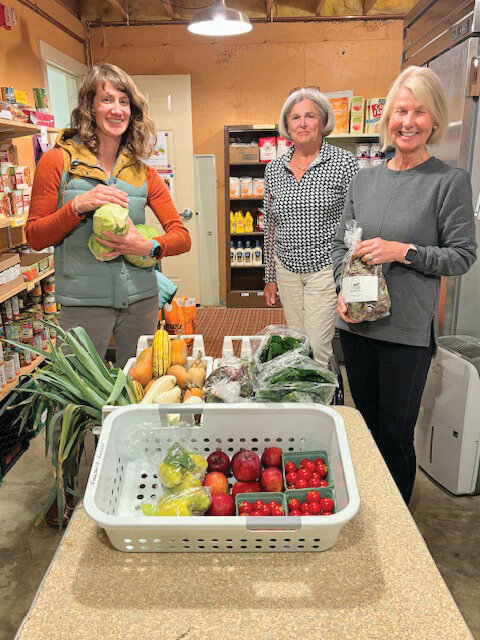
[203,358,253,402]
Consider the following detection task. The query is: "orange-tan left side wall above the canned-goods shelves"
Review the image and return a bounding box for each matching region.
[0,0,84,167]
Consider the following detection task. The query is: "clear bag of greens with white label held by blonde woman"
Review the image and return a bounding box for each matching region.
[342,220,391,322]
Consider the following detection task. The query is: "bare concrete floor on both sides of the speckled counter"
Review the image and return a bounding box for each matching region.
[0,376,480,640]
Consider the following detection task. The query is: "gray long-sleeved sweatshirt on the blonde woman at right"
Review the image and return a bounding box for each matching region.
[332,157,477,347]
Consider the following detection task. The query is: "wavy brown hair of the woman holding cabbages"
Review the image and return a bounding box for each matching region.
[71,64,155,158]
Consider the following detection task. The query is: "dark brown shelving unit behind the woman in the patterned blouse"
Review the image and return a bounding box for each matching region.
[224,124,378,307]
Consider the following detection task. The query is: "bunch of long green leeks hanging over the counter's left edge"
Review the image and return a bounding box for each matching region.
[5,321,137,527]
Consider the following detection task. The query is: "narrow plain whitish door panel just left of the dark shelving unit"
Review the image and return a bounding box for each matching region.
[193,153,220,306]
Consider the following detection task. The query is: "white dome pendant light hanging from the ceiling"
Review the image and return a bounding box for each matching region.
[188,0,252,36]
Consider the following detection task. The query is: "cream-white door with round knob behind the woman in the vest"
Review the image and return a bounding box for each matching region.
[132,75,200,302]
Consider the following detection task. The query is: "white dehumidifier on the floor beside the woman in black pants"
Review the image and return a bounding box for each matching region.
[415,336,480,495]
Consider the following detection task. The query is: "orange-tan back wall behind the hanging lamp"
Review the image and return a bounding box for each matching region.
[91,20,403,299]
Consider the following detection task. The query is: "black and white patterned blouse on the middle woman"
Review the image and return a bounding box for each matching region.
[263,140,358,282]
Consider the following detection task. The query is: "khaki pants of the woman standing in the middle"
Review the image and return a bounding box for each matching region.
[275,258,337,366]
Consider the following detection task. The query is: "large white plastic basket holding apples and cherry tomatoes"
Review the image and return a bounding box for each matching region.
[84,403,360,553]
